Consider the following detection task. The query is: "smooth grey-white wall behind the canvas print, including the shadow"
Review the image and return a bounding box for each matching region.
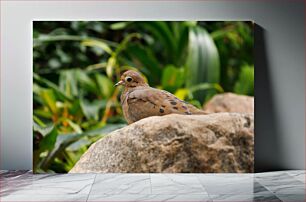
[0,0,305,170]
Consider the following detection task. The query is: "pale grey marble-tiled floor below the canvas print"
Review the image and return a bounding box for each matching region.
[0,170,306,202]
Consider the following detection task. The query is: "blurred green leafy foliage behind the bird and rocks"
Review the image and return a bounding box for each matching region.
[33,21,254,173]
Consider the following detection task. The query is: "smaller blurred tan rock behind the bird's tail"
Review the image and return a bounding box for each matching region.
[204,93,254,113]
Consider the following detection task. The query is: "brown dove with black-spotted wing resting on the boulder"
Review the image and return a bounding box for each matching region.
[115,70,207,124]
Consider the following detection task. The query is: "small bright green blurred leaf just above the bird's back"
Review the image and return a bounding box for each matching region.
[162,65,185,92]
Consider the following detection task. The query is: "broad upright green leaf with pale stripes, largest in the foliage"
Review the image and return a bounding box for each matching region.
[186,26,220,102]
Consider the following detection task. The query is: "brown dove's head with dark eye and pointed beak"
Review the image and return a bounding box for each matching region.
[115,70,148,88]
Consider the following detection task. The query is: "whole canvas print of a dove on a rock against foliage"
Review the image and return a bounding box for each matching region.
[33,21,254,173]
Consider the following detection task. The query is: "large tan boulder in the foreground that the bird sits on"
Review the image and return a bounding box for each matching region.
[70,113,254,173]
